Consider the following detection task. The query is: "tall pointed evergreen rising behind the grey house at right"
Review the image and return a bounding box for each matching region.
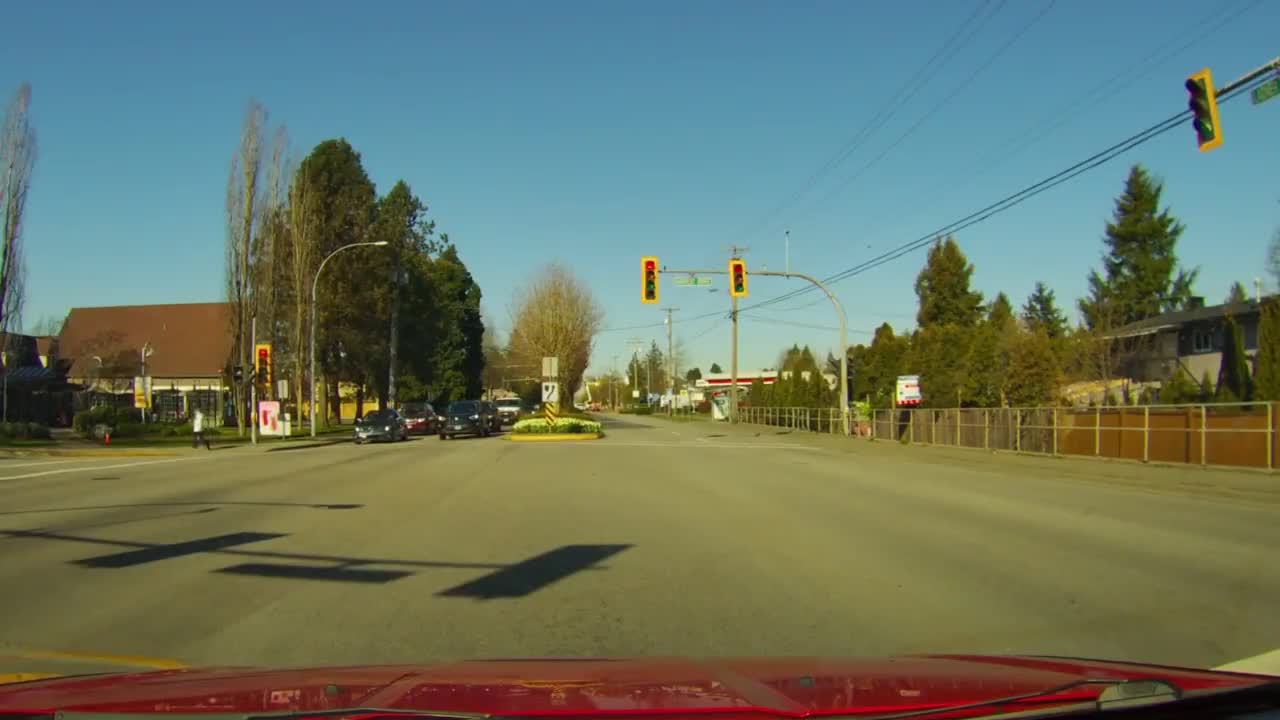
[1080,165,1197,331]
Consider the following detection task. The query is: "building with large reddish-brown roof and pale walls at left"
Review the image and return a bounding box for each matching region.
[56,302,233,421]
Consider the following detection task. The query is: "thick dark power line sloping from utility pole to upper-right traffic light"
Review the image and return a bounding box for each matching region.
[739,73,1266,313]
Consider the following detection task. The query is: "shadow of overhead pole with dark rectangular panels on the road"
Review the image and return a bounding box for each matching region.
[0,525,631,591]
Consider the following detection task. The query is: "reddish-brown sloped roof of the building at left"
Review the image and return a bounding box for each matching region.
[58,302,232,378]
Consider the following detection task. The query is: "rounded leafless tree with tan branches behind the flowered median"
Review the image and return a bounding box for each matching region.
[511,263,604,401]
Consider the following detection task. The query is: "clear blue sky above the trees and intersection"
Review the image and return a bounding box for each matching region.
[0,0,1280,370]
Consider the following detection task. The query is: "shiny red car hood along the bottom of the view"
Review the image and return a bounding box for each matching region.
[0,655,1274,720]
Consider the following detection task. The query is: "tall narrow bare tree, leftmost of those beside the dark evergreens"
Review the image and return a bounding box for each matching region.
[227,100,266,434]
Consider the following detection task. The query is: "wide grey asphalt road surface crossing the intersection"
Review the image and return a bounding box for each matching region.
[0,419,1280,671]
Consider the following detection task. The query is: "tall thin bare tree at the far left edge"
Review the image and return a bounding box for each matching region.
[0,83,36,332]
